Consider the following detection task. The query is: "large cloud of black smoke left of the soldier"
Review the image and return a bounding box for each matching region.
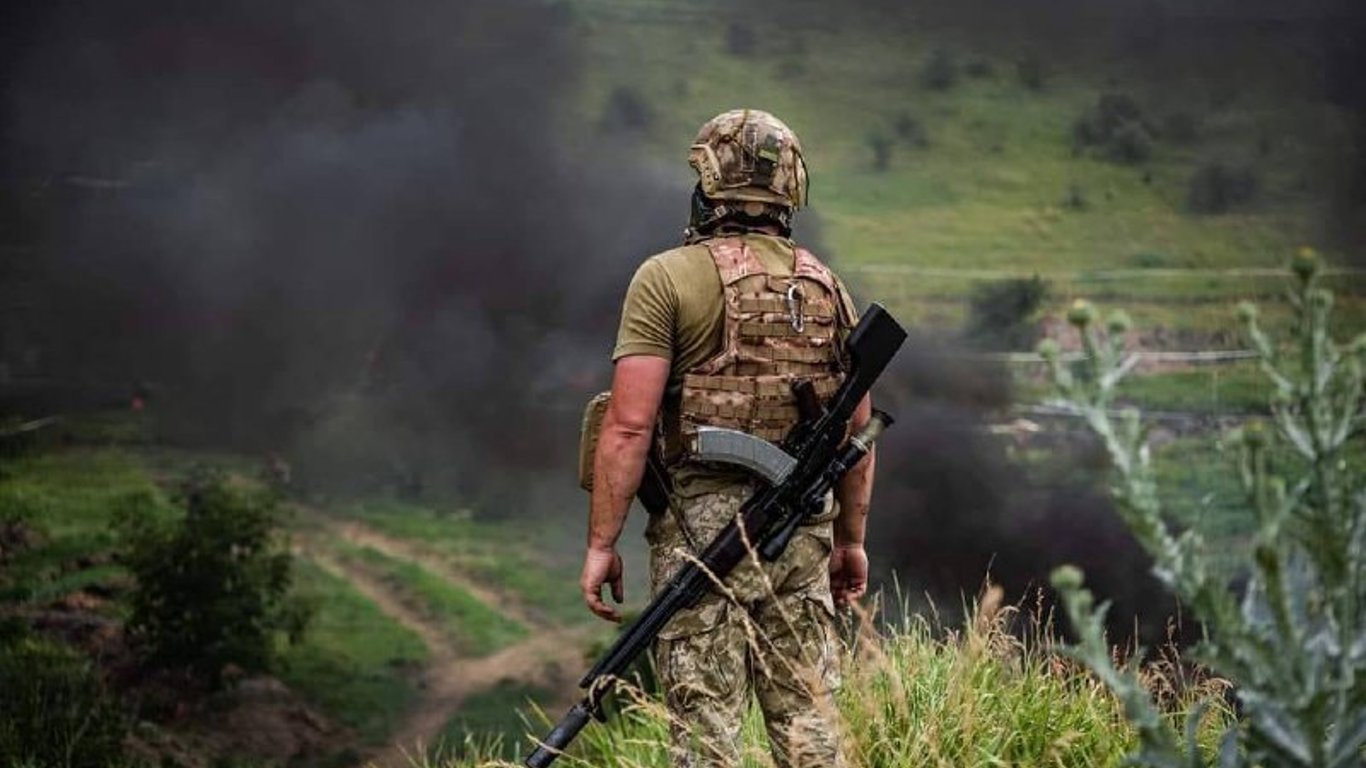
[0,0,687,497]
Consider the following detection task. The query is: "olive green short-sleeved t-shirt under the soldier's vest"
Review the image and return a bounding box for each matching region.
[612,235,854,387]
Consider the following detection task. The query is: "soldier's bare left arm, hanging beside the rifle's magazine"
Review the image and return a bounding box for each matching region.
[579,355,669,622]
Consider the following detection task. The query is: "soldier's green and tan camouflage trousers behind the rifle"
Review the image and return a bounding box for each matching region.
[646,475,844,768]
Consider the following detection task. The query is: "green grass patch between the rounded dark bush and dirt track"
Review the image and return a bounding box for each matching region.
[280,560,428,743]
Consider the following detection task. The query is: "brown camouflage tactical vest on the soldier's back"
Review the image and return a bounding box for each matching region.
[665,238,850,458]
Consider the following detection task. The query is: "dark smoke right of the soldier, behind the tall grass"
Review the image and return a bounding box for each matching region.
[867,333,1199,648]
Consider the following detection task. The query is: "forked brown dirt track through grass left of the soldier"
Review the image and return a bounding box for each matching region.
[301,512,587,768]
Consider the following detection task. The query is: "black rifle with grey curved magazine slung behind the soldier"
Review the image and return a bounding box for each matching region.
[526,303,906,768]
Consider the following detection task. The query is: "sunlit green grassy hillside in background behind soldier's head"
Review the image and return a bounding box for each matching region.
[566,0,1366,337]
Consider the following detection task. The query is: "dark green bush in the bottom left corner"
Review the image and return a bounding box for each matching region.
[0,626,130,768]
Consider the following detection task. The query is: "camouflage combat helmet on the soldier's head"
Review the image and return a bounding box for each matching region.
[687,109,806,209]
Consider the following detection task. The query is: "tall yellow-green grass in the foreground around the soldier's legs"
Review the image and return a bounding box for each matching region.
[425,589,1231,768]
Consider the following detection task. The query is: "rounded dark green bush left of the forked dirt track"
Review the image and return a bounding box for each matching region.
[117,474,307,687]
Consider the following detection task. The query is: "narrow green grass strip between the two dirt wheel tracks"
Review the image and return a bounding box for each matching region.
[336,543,527,656]
